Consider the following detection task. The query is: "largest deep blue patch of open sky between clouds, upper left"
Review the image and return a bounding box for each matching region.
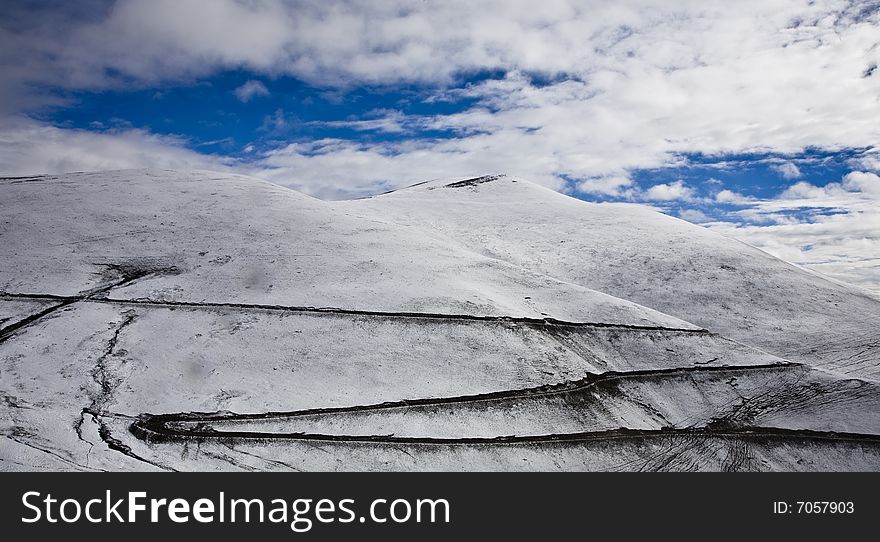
[38,70,478,155]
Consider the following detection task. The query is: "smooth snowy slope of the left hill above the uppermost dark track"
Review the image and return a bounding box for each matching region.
[0,171,693,327]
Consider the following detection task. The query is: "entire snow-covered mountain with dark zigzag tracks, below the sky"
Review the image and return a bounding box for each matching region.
[0,171,880,470]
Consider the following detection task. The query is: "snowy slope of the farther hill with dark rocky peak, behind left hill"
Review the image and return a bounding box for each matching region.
[344,176,880,380]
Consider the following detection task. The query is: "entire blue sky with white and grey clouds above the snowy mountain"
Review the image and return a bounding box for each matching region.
[0,0,880,290]
